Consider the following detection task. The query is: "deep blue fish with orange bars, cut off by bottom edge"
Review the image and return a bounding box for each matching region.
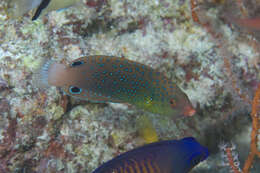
[92,137,209,173]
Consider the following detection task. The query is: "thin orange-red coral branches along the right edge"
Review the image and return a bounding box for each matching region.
[190,0,260,173]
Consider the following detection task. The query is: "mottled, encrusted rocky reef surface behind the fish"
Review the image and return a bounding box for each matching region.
[0,0,260,173]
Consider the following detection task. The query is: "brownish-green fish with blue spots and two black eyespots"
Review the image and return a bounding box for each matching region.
[36,55,195,116]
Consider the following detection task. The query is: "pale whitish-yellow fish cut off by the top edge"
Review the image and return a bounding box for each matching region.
[8,0,81,20]
